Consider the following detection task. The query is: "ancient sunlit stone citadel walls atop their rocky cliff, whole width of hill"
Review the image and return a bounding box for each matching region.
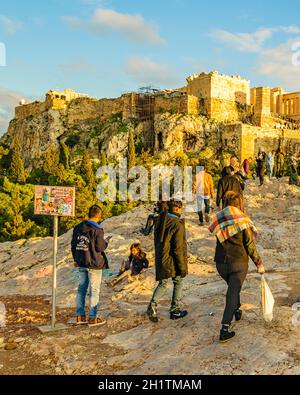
[1,71,300,165]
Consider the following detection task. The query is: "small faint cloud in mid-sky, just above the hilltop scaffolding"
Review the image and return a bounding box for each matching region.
[127,57,178,86]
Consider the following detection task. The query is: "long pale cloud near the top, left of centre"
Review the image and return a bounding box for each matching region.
[63,8,165,45]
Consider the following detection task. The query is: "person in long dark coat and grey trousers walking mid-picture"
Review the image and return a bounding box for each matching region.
[147,200,188,322]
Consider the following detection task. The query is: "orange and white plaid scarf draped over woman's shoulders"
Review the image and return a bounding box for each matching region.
[209,206,257,243]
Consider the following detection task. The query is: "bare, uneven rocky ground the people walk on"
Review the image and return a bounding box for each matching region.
[0,179,300,374]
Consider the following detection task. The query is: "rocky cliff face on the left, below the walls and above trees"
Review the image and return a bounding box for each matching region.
[0,107,130,167]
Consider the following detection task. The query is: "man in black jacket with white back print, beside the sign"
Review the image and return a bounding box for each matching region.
[71,205,108,326]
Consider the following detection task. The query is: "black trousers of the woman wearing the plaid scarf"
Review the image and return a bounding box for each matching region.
[217,263,248,325]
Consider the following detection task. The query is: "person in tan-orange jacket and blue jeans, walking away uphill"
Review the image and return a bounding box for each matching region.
[193,162,214,226]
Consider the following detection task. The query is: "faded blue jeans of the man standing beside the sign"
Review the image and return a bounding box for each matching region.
[76,267,102,318]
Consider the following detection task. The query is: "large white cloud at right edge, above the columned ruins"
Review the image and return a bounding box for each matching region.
[255,37,300,92]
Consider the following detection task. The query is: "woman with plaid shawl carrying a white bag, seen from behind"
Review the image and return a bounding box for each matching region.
[209,192,265,342]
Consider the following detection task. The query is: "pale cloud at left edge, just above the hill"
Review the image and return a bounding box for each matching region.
[0,87,26,135]
